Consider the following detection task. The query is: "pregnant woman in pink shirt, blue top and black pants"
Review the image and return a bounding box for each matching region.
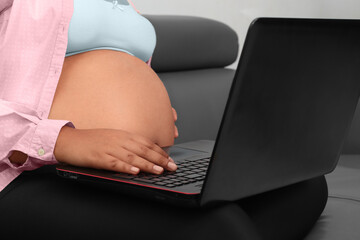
[0,0,327,239]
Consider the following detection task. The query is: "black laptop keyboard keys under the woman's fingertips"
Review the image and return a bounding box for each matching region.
[114,158,210,188]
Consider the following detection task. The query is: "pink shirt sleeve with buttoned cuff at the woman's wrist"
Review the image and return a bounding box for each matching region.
[0,99,75,191]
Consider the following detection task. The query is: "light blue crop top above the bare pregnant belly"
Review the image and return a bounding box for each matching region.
[65,0,156,62]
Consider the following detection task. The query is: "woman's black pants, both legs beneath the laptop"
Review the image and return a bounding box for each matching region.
[0,166,327,240]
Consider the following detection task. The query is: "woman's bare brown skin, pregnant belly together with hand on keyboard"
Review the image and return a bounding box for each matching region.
[9,50,178,174]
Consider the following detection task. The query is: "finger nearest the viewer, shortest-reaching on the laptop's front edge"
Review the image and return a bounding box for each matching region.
[94,154,140,174]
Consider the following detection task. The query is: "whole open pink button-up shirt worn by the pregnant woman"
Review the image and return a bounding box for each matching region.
[0,0,146,191]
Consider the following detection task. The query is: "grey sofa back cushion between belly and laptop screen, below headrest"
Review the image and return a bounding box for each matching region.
[159,68,235,143]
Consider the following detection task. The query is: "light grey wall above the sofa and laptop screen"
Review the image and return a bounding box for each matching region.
[132,0,360,69]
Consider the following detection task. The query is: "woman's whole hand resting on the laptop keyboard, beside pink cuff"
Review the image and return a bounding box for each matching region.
[54,126,177,174]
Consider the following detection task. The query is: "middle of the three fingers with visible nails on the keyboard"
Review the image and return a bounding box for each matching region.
[111,148,164,174]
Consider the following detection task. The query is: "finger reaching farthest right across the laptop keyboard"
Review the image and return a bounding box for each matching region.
[124,143,177,171]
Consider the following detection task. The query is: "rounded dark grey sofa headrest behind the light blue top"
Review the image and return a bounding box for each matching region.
[144,15,239,72]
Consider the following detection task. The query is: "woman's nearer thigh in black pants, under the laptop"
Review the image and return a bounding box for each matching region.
[0,166,260,240]
